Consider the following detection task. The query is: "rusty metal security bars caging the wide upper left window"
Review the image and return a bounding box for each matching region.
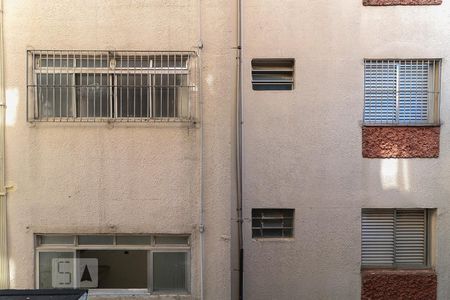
[27,50,196,122]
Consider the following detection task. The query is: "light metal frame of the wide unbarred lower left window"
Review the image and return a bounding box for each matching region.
[34,233,192,295]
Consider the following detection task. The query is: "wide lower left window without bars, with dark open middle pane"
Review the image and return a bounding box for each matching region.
[36,234,190,293]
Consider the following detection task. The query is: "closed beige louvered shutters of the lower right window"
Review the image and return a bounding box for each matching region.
[361,209,429,267]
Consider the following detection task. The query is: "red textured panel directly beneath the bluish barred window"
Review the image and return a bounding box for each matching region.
[362,126,440,158]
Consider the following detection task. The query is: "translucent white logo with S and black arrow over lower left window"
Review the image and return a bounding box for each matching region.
[52,258,98,288]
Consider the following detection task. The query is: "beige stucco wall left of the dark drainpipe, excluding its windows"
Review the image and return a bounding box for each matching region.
[4,0,235,299]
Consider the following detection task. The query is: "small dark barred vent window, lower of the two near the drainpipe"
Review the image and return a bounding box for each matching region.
[252,209,294,238]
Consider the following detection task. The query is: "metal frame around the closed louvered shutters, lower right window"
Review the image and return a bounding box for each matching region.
[360,208,435,270]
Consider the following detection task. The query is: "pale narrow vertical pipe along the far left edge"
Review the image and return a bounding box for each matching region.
[0,0,9,289]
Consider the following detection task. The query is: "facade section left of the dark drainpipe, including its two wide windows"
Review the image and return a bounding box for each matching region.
[3,0,236,299]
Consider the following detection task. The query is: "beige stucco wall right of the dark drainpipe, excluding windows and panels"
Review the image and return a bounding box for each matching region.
[244,0,450,300]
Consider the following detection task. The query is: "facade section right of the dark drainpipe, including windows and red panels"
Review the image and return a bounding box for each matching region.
[243,0,450,299]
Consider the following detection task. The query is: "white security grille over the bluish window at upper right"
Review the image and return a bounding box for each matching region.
[364,59,441,125]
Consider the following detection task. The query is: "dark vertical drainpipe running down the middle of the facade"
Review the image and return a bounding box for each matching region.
[236,0,244,300]
